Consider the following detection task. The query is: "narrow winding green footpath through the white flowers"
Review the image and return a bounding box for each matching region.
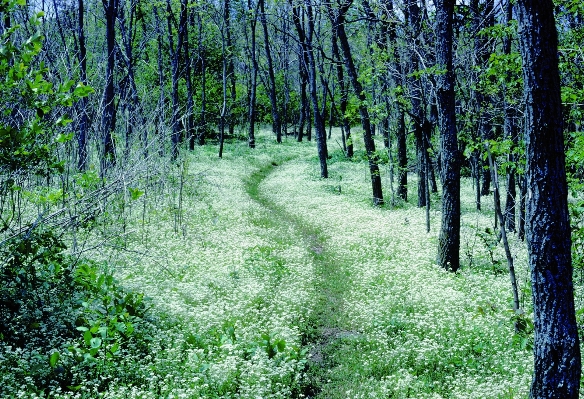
[245,159,357,398]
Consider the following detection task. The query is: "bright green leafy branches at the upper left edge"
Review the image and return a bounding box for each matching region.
[0,9,93,176]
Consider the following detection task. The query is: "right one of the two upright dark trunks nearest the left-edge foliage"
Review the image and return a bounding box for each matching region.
[101,0,118,175]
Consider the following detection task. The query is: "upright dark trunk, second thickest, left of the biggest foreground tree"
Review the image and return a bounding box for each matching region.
[436,0,460,272]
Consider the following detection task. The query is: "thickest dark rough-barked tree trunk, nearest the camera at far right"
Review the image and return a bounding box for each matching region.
[518,0,581,399]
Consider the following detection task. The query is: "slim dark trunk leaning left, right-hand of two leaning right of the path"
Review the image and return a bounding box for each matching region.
[331,1,383,206]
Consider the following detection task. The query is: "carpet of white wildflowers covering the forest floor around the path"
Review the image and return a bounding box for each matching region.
[8,130,572,399]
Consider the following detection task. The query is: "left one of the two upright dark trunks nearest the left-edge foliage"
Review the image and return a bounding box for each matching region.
[77,0,89,170]
